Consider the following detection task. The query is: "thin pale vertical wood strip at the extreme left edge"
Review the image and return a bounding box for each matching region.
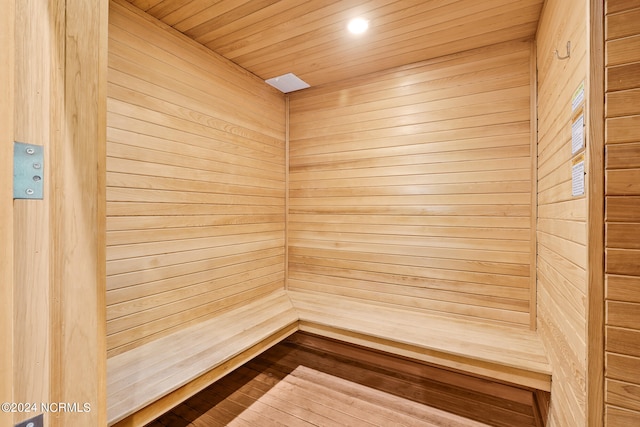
[0,0,15,426]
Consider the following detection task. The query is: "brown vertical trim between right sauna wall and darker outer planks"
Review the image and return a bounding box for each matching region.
[586,0,604,427]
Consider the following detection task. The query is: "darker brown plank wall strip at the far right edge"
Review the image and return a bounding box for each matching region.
[605,0,640,427]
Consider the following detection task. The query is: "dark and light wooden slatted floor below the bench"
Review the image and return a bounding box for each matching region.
[149,333,543,427]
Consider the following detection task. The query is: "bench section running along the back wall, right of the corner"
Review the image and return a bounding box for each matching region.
[289,290,551,391]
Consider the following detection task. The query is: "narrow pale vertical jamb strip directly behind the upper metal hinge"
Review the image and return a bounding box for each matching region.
[13,1,52,425]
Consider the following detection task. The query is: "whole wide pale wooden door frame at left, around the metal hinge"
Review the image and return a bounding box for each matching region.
[10,0,108,427]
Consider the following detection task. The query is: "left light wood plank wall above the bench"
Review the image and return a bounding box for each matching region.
[107,1,285,356]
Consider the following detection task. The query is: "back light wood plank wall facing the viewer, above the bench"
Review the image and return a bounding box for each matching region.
[288,42,535,327]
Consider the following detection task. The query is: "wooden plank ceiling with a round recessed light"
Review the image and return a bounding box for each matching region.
[128,0,544,86]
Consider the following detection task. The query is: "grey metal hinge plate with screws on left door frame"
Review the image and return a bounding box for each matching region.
[13,142,44,199]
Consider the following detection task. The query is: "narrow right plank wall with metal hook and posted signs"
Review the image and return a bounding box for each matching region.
[537,0,588,426]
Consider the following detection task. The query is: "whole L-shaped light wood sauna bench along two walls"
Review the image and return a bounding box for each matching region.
[107,290,551,427]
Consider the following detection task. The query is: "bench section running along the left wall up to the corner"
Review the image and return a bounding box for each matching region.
[107,290,298,426]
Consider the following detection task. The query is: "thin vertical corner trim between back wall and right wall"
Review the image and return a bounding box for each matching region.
[529,40,538,331]
